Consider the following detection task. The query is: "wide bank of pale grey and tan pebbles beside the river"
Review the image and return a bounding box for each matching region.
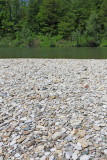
[0,59,107,160]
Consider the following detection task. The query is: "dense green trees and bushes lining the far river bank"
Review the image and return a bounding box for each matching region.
[0,0,107,47]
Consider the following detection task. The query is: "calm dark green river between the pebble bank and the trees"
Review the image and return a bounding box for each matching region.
[0,47,107,59]
